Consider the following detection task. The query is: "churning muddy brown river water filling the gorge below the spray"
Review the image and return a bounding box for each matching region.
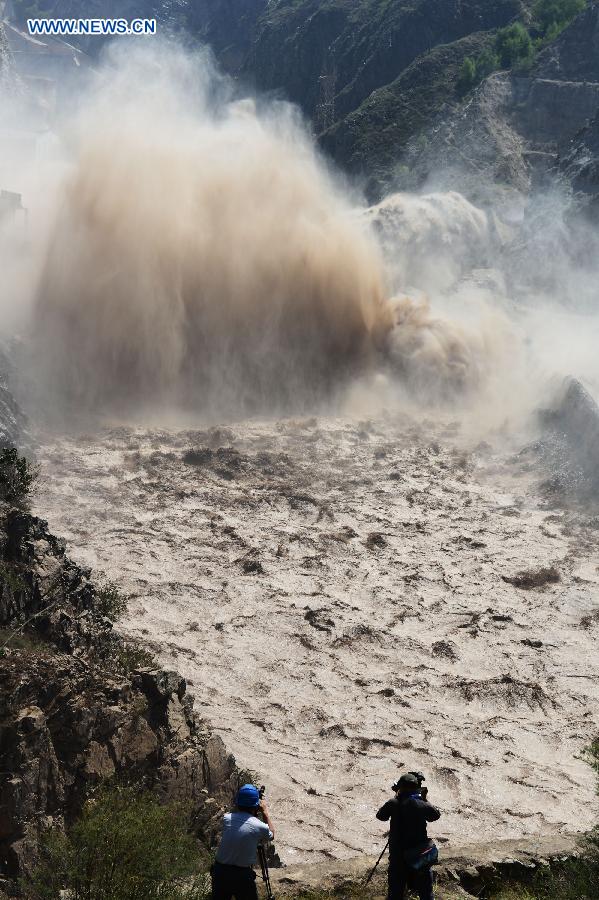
[31,416,599,863]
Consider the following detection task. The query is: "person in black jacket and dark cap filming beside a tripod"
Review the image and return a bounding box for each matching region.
[376,772,441,900]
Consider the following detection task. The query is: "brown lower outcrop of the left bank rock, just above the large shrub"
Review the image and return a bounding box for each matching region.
[0,652,234,876]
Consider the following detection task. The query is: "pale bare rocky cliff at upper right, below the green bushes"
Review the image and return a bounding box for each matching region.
[388,2,599,199]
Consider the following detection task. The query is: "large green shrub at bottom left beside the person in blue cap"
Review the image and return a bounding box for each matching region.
[23,786,209,900]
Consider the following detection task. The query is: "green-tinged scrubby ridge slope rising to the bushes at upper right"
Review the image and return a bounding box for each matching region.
[316,0,586,190]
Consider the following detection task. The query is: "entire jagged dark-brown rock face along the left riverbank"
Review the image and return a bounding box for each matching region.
[0,504,236,878]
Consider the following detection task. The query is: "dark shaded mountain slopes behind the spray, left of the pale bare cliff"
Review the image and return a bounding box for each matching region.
[8,0,530,174]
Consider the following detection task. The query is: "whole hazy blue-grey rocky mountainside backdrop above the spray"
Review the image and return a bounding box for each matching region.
[8,0,599,204]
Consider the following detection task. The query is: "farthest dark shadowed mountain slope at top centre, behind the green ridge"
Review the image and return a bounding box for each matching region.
[241,0,523,126]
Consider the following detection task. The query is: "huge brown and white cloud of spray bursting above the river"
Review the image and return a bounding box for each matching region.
[0,43,596,427]
